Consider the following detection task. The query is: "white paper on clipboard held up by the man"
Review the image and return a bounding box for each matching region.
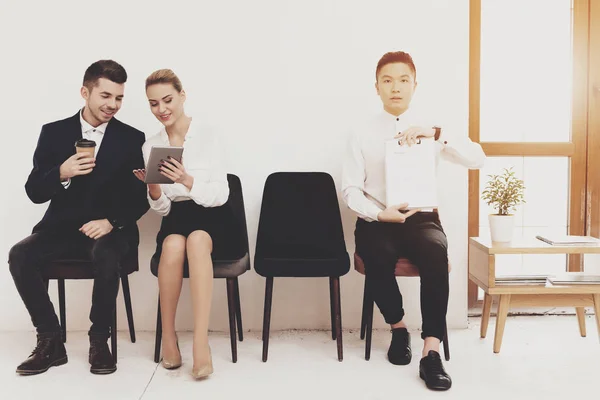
[385,139,438,209]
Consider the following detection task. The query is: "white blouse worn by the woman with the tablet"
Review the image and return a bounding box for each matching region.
[142,120,229,216]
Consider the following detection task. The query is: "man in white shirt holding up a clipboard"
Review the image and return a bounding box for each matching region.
[342,52,485,390]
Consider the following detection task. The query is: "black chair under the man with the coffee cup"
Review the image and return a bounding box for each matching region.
[42,252,139,363]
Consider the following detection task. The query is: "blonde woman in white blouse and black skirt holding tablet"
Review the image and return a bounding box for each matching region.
[134,69,232,378]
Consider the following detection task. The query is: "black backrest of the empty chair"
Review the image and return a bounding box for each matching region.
[256,172,346,258]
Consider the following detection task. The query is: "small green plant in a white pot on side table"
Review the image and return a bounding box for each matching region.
[481,167,525,242]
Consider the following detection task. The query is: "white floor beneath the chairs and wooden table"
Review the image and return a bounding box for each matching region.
[0,316,600,400]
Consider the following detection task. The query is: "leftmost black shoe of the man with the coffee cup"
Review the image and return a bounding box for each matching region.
[17,333,68,375]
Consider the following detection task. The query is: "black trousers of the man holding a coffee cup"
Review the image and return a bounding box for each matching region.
[8,231,132,338]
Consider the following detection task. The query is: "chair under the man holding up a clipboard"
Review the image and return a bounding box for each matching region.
[354,253,451,361]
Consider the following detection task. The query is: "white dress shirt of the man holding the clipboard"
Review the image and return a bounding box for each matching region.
[342,109,485,222]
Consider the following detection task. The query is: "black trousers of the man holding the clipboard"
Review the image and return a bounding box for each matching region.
[354,212,449,340]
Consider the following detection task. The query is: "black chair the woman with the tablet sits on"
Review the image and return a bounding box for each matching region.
[150,174,250,363]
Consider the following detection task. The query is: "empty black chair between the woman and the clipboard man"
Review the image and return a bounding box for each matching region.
[254,172,350,362]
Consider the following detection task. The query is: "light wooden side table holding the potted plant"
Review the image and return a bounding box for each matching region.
[469,237,600,353]
